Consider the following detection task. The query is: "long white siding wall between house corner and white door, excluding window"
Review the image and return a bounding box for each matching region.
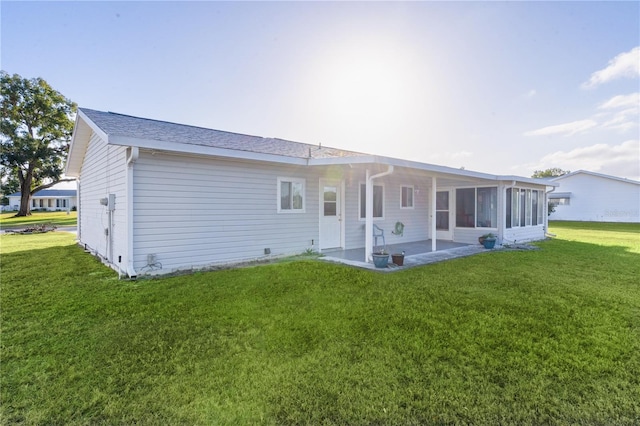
[133,150,321,271]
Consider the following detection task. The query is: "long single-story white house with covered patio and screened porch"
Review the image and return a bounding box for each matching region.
[65,108,556,276]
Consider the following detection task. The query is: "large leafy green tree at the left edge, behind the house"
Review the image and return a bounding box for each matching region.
[0,71,77,216]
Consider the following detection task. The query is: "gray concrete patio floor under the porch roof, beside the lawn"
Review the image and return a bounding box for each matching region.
[320,240,490,272]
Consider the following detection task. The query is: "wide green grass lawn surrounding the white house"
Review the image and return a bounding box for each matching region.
[0,223,640,425]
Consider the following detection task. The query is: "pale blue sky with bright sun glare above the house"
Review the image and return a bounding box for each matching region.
[0,0,640,180]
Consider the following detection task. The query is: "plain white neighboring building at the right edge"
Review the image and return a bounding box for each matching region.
[549,170,640,223]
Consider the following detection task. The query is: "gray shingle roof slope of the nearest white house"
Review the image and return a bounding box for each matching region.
[80,108,366,158]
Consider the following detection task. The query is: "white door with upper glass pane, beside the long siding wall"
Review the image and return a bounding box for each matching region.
[320,179,343,250]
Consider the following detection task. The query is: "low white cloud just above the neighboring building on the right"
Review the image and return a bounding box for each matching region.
[527,140,640,180]
